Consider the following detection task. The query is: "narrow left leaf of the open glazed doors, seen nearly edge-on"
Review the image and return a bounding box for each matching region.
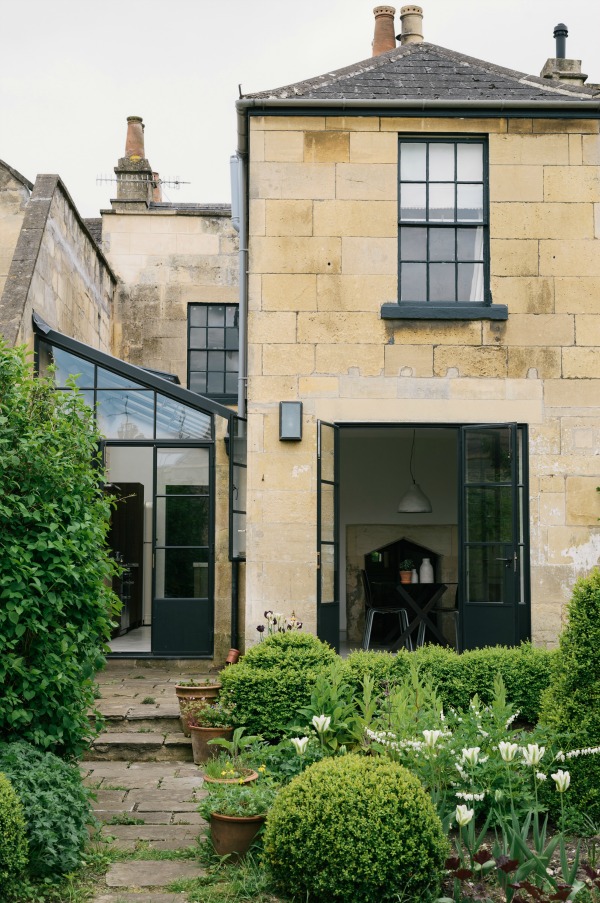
[317,420,340,651]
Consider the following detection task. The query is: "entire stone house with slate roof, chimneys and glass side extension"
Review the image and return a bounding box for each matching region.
[0,6,600,665]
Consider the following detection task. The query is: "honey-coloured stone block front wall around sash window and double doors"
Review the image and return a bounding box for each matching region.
[247,111,600,644]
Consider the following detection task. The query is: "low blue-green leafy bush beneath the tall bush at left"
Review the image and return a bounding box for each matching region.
[0,741,92,875]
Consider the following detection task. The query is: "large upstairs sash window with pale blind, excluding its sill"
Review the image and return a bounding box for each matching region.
[398,136,491,310]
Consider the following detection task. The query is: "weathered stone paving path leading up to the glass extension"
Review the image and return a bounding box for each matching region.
[81,666,217,903]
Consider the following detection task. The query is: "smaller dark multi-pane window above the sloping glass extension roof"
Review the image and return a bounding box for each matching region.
[188,304,239,404]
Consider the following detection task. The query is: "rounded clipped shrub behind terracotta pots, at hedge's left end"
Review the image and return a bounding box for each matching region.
[221,633,337,740]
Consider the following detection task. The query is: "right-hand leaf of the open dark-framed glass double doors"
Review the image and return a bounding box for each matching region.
[460,423,529,649]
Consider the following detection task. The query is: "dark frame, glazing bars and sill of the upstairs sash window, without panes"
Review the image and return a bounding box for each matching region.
[381,134,508,320]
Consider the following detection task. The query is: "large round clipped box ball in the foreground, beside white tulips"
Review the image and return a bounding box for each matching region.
[264,755,447,903]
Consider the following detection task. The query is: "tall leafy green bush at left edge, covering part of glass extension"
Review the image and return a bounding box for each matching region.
[0,341,116,756]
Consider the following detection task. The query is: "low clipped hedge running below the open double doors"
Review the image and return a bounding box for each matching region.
[342,643,556,724]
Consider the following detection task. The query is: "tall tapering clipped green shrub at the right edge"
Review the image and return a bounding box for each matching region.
[540,568,600,823]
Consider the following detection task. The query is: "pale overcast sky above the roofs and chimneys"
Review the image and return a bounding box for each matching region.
[0,0,600,216]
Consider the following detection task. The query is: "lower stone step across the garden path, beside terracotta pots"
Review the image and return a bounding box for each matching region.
[83,729,192,762]
